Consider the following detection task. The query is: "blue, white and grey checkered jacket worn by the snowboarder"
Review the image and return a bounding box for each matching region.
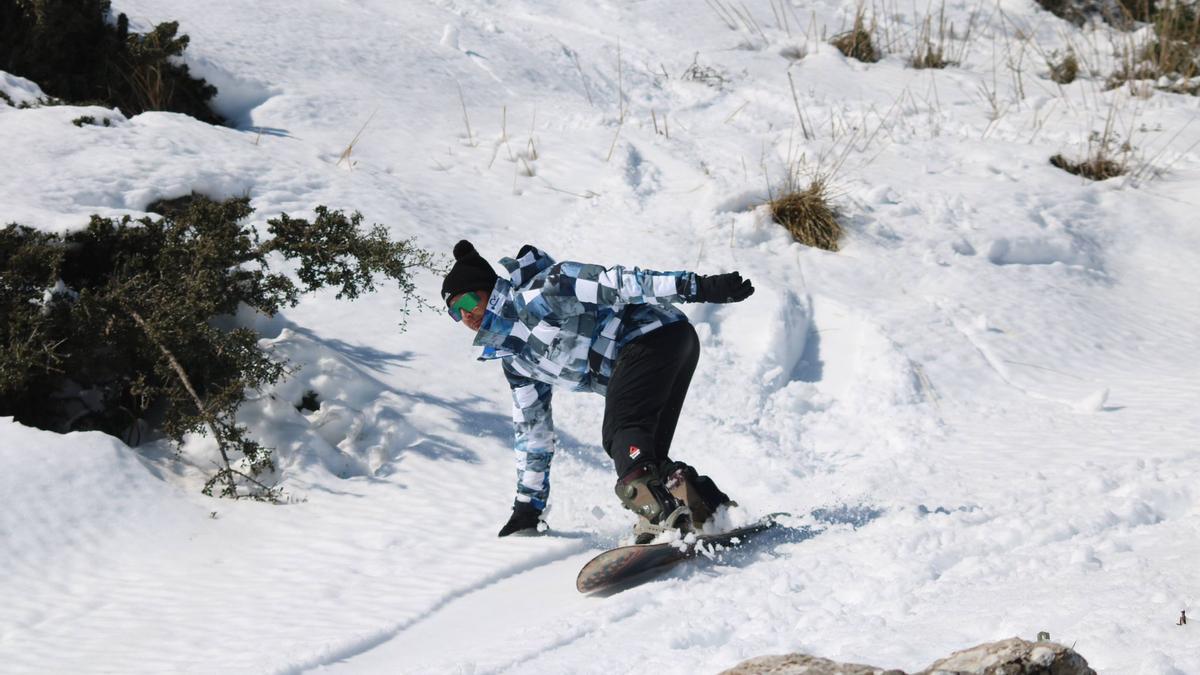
[475,245,696,509]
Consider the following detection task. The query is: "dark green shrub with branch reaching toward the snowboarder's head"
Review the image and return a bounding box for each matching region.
[0,192,433,497]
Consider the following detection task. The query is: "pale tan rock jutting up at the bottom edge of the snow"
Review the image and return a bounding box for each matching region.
[721,638,1096,675]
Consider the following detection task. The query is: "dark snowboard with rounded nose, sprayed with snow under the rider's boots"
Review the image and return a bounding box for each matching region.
[575,513,787,593]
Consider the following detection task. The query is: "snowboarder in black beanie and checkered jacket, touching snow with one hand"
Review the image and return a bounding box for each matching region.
[442,240,754,543]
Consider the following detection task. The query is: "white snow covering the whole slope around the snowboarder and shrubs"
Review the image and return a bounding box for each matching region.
[0,0,1200,675]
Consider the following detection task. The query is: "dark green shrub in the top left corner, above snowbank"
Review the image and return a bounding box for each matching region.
[0,0,222,124]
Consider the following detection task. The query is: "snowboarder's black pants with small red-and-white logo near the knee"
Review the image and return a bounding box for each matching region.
[602,321,700,477]
